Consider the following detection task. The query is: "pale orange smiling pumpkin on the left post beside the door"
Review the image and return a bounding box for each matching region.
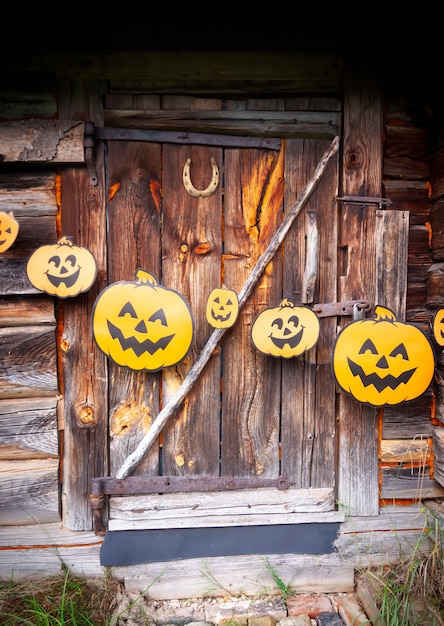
[26,237,97,298]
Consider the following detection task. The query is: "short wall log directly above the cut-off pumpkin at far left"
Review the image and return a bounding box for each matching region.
[0,171,57,219]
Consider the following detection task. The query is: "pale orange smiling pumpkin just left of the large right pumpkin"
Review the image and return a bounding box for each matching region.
[251,298,320,358]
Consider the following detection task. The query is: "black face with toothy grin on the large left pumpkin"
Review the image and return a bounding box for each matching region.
[108,302,175,357]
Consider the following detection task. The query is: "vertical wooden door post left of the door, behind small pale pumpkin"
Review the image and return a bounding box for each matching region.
[58,81,108,530]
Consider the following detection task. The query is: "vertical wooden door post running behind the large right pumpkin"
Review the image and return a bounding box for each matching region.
[337,57,383,515]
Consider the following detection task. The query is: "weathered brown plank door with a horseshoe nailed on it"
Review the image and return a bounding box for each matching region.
[98,96,338,528]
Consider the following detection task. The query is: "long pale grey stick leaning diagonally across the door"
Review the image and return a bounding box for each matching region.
[116,137,339,479]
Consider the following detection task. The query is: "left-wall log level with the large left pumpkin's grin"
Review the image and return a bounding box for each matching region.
[0,326,58,398]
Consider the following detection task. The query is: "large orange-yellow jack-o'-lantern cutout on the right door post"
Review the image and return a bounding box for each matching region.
[332,305,435,407]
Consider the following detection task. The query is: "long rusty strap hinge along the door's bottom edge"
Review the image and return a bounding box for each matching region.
[89,476,291,536]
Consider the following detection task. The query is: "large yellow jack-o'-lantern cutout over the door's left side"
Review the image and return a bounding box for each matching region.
[92,268,194,372]
